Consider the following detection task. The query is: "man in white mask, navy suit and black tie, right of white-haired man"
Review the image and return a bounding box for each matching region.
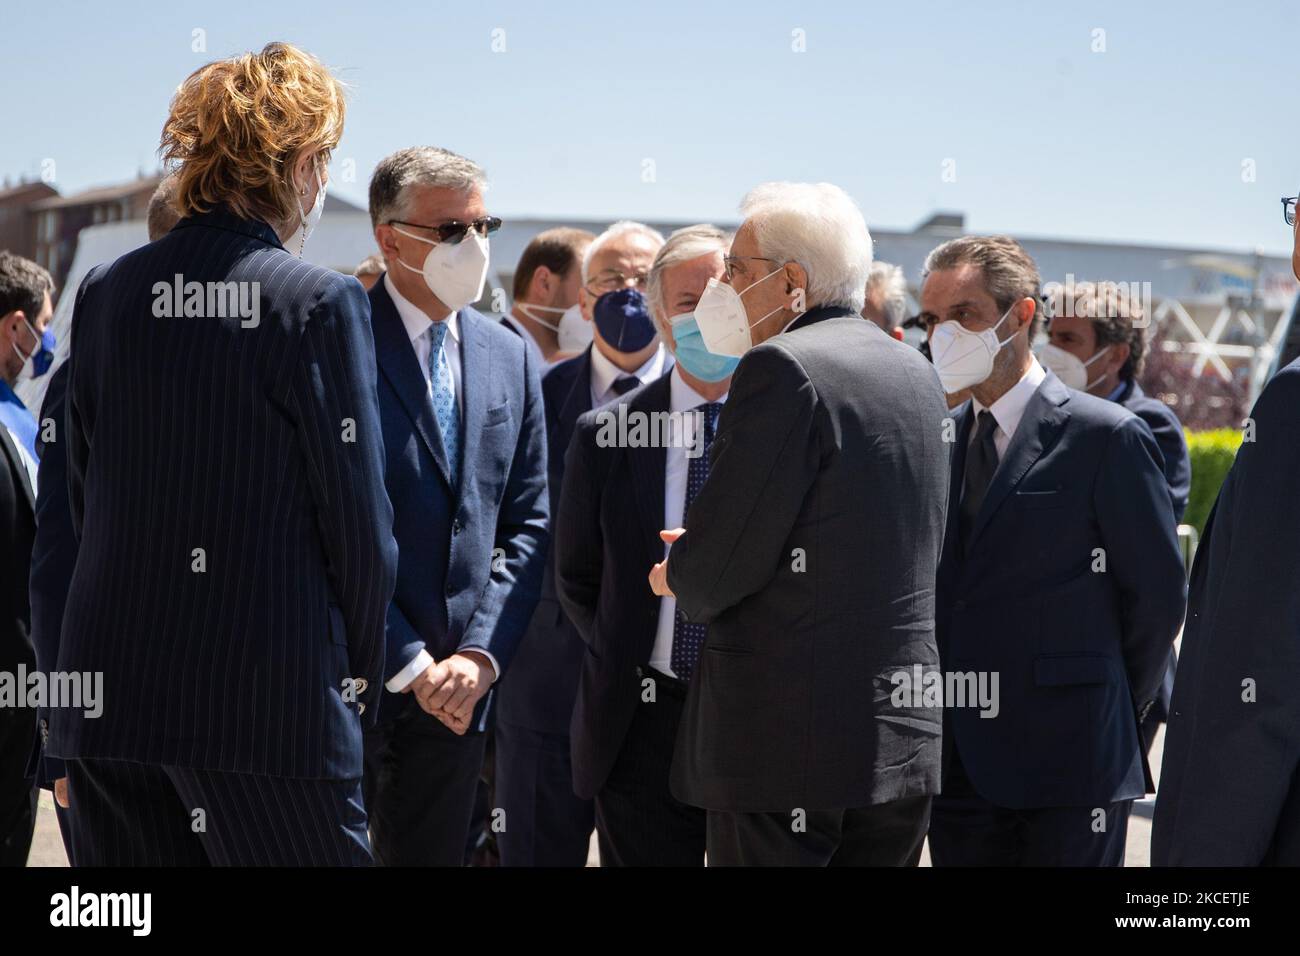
[920,235,1183,866]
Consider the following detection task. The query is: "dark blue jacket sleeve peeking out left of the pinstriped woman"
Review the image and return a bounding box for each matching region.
[30,362,77,786]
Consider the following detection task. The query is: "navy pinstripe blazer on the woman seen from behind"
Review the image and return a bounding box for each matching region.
[48,207,397,779]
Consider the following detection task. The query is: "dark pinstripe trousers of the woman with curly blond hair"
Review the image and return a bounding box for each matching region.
[68,760,372,866]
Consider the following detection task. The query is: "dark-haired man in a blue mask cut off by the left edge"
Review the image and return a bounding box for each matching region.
[0,251,55,866]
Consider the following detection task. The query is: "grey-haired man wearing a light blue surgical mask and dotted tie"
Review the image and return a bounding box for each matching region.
[554,225,736,866]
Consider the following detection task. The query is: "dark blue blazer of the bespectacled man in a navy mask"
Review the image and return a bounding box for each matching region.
[497,348,592,736]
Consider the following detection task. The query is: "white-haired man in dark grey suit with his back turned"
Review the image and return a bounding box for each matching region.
[650,183,950,865]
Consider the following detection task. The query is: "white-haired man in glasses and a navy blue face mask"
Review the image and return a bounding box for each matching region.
[495,221,672,866]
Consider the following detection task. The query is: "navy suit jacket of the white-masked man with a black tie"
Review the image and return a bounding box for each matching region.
[936,372,1184,809]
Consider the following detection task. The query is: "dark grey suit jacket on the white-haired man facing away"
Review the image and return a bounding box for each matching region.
[668,308,952,812]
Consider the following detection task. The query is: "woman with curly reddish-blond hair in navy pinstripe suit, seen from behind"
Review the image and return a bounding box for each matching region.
[38,43,397,865]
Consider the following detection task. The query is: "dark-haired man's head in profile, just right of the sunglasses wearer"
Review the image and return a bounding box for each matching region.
[502,228,595,362]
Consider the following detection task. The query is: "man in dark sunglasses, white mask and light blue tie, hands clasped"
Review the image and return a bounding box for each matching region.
[364,147,549,866]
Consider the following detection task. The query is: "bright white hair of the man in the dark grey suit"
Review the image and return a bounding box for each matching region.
[740,182,871,312]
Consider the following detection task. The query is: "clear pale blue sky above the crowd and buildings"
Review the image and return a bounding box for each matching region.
[10,0,1300,251]
